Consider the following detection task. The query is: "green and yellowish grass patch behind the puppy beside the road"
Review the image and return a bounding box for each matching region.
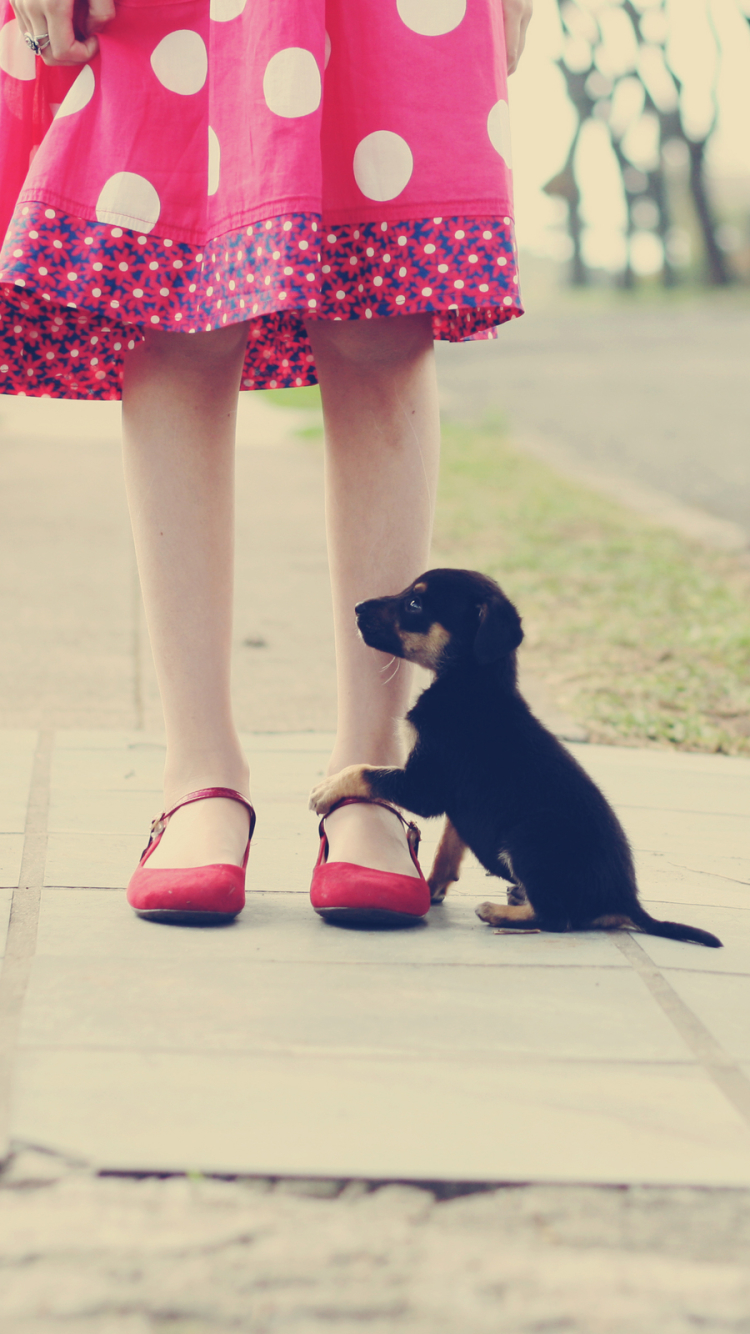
[435,423,750,755]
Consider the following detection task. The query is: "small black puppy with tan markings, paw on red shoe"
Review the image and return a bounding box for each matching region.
[310,570,722,946]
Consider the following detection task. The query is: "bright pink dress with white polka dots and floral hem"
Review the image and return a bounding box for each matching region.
[0,0,522,399]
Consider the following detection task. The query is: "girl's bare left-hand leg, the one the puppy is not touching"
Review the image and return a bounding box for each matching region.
[123,324,248,867]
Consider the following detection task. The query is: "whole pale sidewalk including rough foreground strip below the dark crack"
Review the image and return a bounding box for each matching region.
[0,386,750,1334]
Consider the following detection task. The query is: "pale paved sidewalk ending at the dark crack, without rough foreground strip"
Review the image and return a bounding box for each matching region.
[0,396,750,1186]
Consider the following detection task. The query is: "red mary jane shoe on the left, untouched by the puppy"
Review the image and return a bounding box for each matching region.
[128,787,255,926]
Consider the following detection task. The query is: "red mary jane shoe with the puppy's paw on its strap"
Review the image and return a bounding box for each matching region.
[310,796,430,926]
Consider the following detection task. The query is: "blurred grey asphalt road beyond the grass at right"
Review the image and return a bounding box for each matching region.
[439,293,750,530]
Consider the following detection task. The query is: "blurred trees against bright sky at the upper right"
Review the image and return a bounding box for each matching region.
[511,0,750,288]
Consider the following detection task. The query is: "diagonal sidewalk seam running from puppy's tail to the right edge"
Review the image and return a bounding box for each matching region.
[614,931,750,1126]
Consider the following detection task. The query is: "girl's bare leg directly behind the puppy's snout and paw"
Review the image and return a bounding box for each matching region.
[308,315,440,875]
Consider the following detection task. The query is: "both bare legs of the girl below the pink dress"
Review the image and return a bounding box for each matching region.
[123,316,439,874]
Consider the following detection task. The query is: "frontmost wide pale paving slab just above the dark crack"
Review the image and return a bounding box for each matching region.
[15,1045,750,1186]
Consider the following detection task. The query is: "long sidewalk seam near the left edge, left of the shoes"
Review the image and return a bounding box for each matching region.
[0,728,55,1153]
